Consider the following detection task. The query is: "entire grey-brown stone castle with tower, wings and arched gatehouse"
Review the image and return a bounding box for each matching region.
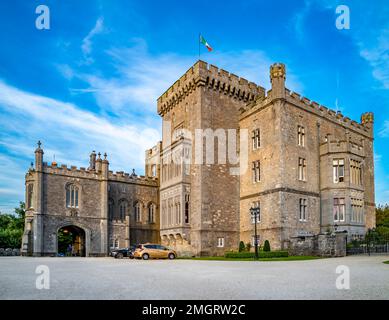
[22,61,375,256]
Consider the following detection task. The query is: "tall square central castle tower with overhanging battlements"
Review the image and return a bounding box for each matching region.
[158,61,264,255]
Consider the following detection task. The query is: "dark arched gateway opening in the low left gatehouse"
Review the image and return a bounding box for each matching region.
[57,225,86,257]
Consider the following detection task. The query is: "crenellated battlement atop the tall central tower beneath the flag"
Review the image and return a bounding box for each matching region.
[157,60,265,115]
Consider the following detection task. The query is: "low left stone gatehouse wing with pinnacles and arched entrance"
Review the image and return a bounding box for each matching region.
[22,144,159,256]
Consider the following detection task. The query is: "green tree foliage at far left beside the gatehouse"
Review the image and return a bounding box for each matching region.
[0,202,26,248]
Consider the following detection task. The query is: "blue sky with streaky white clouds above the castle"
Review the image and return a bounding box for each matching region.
[0,0,389,212]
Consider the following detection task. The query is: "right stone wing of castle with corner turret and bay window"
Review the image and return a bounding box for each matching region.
[240,64,375,249]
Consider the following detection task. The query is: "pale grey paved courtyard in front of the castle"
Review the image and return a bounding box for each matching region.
[0,256,389,299]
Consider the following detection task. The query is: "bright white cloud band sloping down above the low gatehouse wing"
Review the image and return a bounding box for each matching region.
[0,81,160,210]
